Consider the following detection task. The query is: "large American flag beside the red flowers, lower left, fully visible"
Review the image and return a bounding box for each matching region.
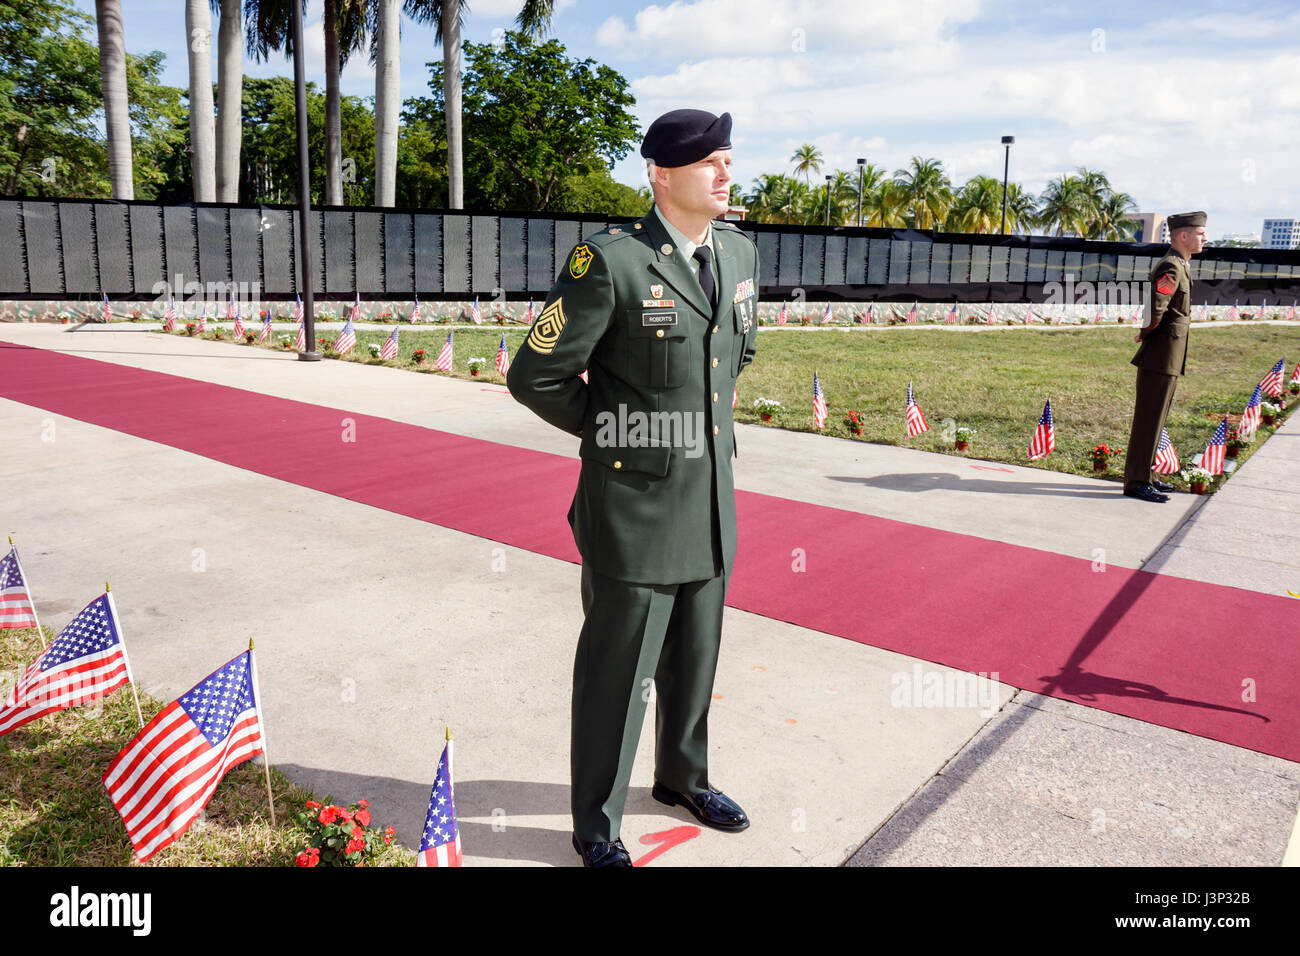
[103,650,264,862]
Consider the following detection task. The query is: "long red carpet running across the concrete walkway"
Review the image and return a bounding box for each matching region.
[0,342,1300,761]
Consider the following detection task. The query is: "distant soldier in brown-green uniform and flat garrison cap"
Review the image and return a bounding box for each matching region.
[1125,212,1205,502]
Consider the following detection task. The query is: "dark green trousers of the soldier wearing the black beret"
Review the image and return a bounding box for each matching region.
[569,564,727,842]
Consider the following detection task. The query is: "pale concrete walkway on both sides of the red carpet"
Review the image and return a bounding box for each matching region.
[0,324,1300,865]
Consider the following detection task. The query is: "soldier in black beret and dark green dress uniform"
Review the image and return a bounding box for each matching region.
[507,109,758,866]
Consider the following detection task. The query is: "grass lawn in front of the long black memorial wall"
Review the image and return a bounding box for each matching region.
[165,324,1300,484]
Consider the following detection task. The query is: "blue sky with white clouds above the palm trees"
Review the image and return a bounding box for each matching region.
[77,0,1300,237]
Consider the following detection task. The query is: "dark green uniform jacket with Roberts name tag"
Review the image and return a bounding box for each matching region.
[506,211,758,584]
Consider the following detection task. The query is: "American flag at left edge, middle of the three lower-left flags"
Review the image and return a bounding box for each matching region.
[0,592,131,735]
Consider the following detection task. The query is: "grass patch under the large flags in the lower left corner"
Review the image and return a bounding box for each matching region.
[0,628,415,866]
